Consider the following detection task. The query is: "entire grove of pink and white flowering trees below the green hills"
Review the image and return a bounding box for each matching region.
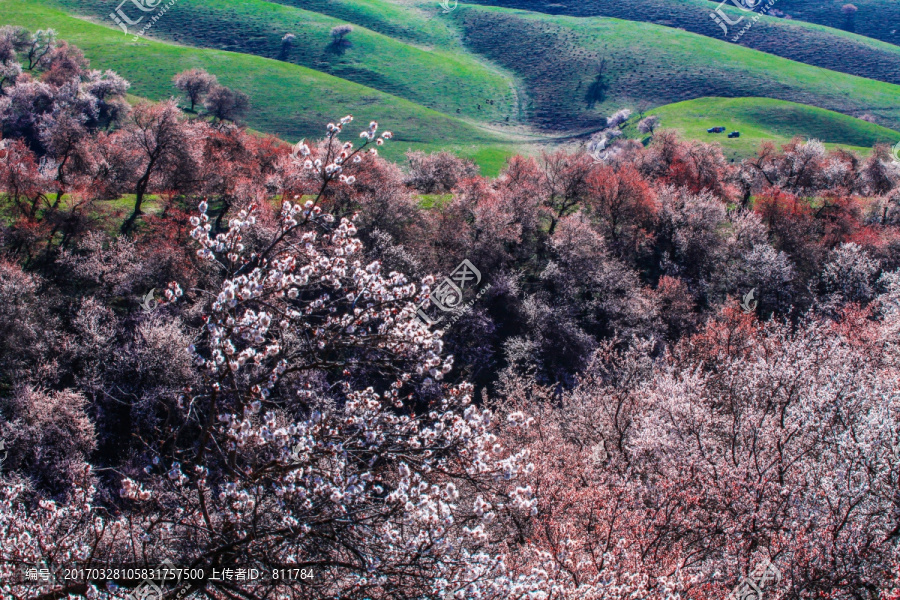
[0,26,900,600]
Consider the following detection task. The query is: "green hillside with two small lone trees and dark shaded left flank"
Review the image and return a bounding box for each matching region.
[37,0,516,122]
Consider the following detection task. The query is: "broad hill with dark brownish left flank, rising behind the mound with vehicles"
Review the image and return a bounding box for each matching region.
[453,6,900,131]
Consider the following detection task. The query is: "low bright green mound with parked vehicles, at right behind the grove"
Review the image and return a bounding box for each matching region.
[625,98,900,160]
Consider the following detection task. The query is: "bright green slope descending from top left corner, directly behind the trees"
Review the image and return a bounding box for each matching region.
[0,0,506,172]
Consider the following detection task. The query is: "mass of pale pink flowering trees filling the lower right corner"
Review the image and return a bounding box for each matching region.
[500,308,900,598]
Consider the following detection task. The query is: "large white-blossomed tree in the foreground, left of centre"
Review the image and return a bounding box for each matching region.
[3,118,529,598]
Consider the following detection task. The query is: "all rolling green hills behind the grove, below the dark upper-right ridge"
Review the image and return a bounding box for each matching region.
[0,0,900,175]
